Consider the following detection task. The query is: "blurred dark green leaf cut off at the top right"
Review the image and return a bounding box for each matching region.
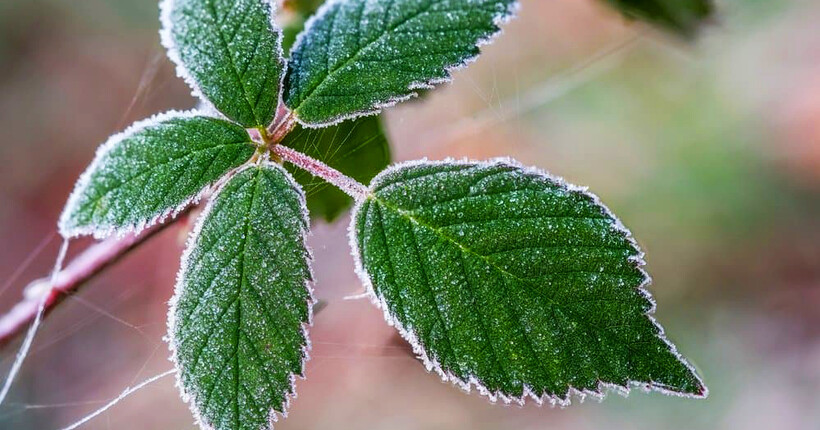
[605,0,714,37]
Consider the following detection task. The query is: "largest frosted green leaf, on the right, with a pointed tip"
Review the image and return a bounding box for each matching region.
[351,161,706,404]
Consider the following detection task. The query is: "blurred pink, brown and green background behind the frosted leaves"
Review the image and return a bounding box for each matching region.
[0,0,820,430]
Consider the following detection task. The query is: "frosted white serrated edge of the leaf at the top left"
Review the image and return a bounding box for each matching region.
[159,0,288,127]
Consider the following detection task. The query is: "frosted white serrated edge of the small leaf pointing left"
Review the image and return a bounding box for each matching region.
[57,109,250,239]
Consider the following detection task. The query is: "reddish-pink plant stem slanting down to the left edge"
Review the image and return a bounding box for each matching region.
[0,215,185,348]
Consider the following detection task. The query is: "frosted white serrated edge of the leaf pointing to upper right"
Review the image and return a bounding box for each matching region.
[282,0,521,128]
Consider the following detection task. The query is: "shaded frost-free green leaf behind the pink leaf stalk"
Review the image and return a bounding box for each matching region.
[281,116,390,222]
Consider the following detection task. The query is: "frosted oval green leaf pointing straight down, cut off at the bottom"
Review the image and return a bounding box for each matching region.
[168,164,314,430]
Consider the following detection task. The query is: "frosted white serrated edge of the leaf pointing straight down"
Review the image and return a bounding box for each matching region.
[163,161,316,430]
